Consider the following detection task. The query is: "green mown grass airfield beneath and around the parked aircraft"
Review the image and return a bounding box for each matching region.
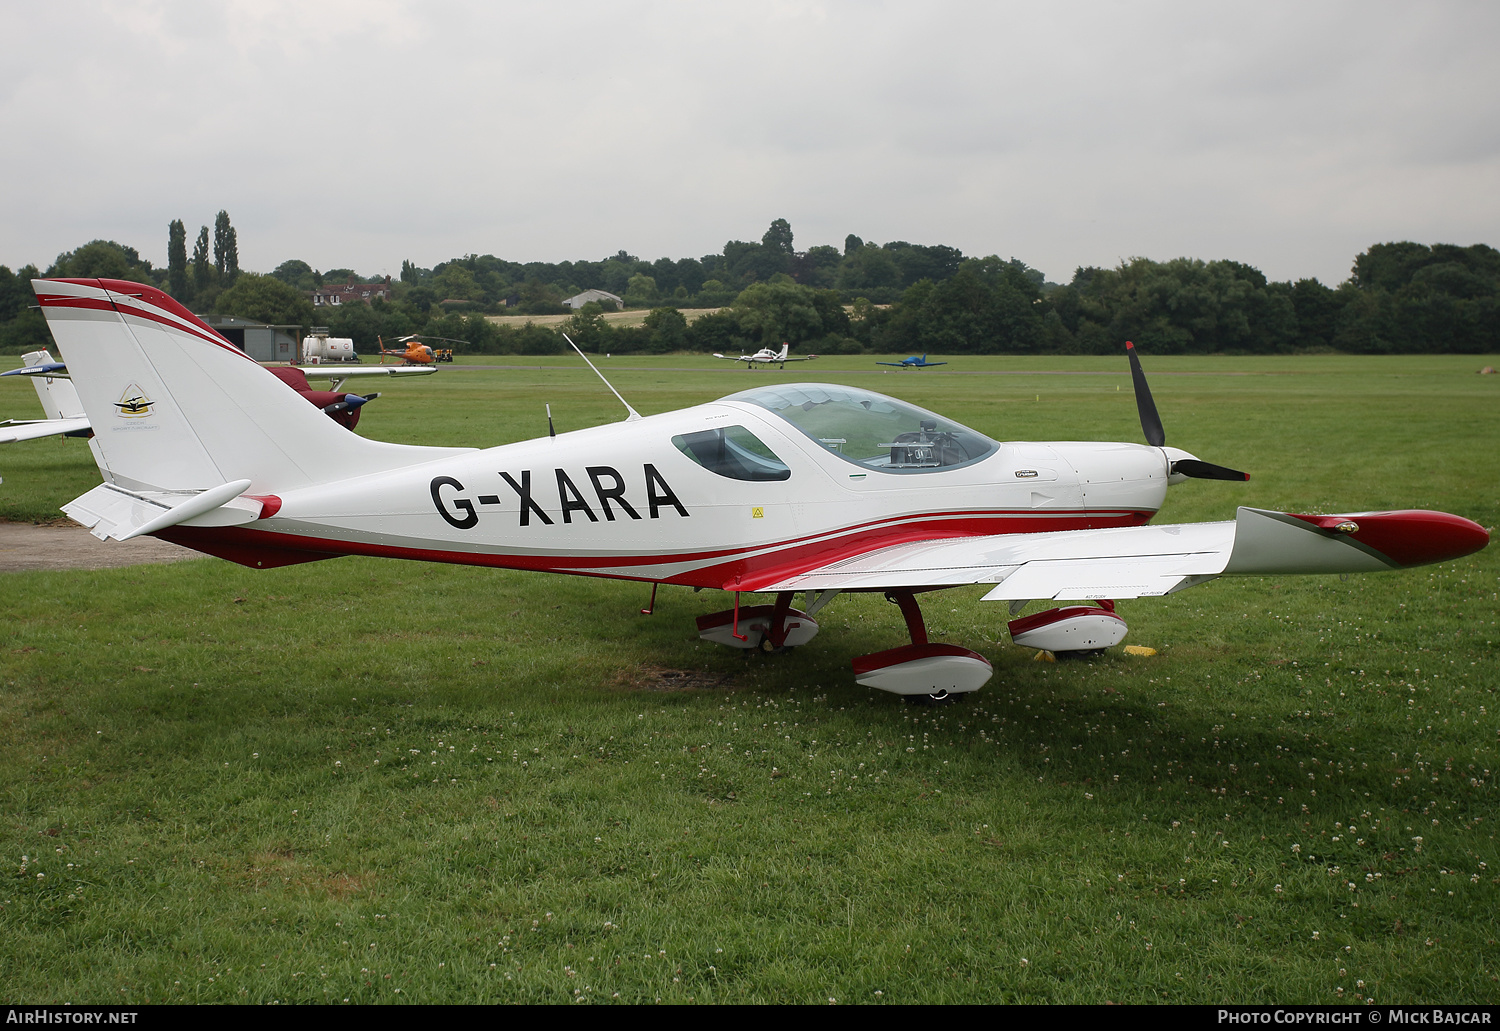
[0,356,1500,1002]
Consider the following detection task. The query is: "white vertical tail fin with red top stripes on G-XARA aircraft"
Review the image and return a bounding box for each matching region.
[32,279,456,494]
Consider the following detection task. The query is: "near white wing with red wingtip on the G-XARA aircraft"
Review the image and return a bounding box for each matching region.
[740,507,1490,602]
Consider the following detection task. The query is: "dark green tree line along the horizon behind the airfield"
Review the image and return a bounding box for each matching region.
[0,212,1500,354]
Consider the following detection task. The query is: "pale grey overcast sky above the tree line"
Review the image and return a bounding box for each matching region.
[0,0,1500,284]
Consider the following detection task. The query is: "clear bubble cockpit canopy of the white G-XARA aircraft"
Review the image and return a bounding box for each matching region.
[725,383,999,473]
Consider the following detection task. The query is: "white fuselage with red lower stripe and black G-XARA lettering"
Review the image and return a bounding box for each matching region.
[195,399,1167,590]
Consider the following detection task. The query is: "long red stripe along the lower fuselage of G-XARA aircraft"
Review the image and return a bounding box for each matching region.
[156,512,1152,591]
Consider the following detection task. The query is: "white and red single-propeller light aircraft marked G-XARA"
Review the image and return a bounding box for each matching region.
[33,279,1490,699]
